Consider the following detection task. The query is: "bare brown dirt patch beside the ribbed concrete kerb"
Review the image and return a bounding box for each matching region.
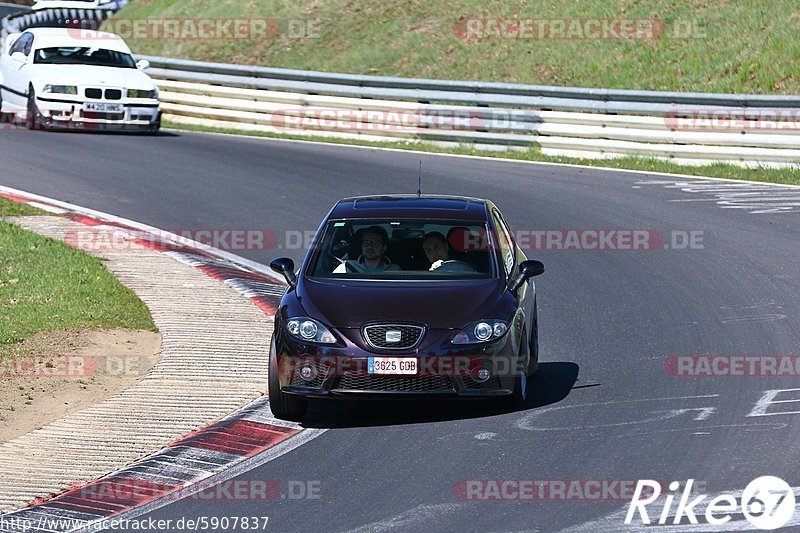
[0,329,161,443]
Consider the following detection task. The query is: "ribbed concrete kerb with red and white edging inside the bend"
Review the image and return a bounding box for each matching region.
[0,187,324,532]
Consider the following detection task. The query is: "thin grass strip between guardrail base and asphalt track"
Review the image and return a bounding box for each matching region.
[164,121,800,185]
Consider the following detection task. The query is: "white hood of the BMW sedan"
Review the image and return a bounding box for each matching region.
[32,65,155,90]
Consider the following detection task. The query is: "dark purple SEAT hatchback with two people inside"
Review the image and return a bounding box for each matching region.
[269,195,544,420]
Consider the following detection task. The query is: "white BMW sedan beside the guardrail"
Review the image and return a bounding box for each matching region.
[0,28,161,133]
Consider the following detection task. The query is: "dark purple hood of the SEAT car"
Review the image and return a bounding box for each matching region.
[298,278,505,329]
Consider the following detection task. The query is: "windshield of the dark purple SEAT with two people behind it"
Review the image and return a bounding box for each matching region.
[307,220,495,281]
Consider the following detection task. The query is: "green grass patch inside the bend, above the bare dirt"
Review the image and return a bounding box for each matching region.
[0,220,156,356]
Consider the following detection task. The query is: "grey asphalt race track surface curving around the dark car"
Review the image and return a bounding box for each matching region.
[0,131,800,531]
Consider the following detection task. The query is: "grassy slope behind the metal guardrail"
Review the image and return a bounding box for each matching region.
[118,0,800,94]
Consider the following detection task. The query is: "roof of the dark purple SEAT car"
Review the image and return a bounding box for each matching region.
[329,194,491,222]
